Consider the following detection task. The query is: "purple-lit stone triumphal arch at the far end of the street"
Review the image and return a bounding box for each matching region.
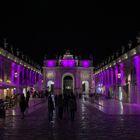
[43,51,94,94]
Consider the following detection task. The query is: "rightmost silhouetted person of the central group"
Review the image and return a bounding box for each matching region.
[69,93,77,121]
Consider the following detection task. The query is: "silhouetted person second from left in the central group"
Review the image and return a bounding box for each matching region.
[58,94,63,120]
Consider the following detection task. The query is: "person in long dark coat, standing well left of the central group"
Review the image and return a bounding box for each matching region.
[19,94,26,119]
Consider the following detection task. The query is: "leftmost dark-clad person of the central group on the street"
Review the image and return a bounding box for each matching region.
[48,94,54,121]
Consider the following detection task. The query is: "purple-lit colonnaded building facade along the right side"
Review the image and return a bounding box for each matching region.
[94,44,140,104]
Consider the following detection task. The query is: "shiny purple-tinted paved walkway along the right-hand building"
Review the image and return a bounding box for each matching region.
[89,98,140,115]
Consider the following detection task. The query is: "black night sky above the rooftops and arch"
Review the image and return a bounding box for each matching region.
[0,1,140,66]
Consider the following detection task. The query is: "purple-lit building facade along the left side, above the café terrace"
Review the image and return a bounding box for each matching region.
[0,48,42,99]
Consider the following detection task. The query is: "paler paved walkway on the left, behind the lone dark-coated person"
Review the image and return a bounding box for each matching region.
[6,98,46,117]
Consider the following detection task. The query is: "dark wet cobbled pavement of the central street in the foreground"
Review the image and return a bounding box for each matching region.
[0,99,140,140]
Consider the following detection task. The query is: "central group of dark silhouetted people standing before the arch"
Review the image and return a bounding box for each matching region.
[47,92,77,121]
